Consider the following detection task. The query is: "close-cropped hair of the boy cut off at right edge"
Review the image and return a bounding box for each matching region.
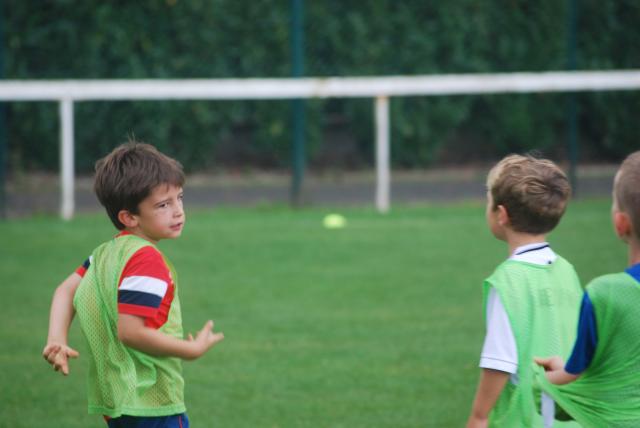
[613,151,640,239]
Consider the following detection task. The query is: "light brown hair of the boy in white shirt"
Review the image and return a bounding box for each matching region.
[487,155,571,234]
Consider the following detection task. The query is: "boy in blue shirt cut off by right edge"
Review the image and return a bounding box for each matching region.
[536,151,640,428]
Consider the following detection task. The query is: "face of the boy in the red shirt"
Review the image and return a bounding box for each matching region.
[131,184,185,243]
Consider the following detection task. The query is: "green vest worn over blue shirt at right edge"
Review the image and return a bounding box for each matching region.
[537,273,640,428]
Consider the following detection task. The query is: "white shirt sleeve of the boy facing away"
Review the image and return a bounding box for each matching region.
[480,287,518,374]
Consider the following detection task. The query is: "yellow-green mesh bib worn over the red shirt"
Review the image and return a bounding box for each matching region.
[73,235,185,417]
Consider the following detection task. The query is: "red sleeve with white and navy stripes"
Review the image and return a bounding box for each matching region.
[118,246,171,318]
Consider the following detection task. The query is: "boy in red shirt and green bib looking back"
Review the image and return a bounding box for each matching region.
[43,142,224,428]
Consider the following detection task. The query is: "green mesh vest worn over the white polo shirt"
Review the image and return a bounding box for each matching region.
[484,257,582,428]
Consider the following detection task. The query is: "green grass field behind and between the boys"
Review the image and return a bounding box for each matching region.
[0,201,626,428]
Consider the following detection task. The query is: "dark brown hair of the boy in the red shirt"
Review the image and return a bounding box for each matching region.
[93,141,184,230]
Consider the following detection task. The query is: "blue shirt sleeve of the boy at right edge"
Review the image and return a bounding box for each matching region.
[564,293,598,375]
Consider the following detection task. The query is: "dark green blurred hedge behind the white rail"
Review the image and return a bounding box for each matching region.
[2,0,640,172]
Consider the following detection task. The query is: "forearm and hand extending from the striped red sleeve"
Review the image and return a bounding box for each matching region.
[118,314,224,360]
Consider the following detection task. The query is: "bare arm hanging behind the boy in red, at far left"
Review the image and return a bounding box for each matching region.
[42,272,82,376]
